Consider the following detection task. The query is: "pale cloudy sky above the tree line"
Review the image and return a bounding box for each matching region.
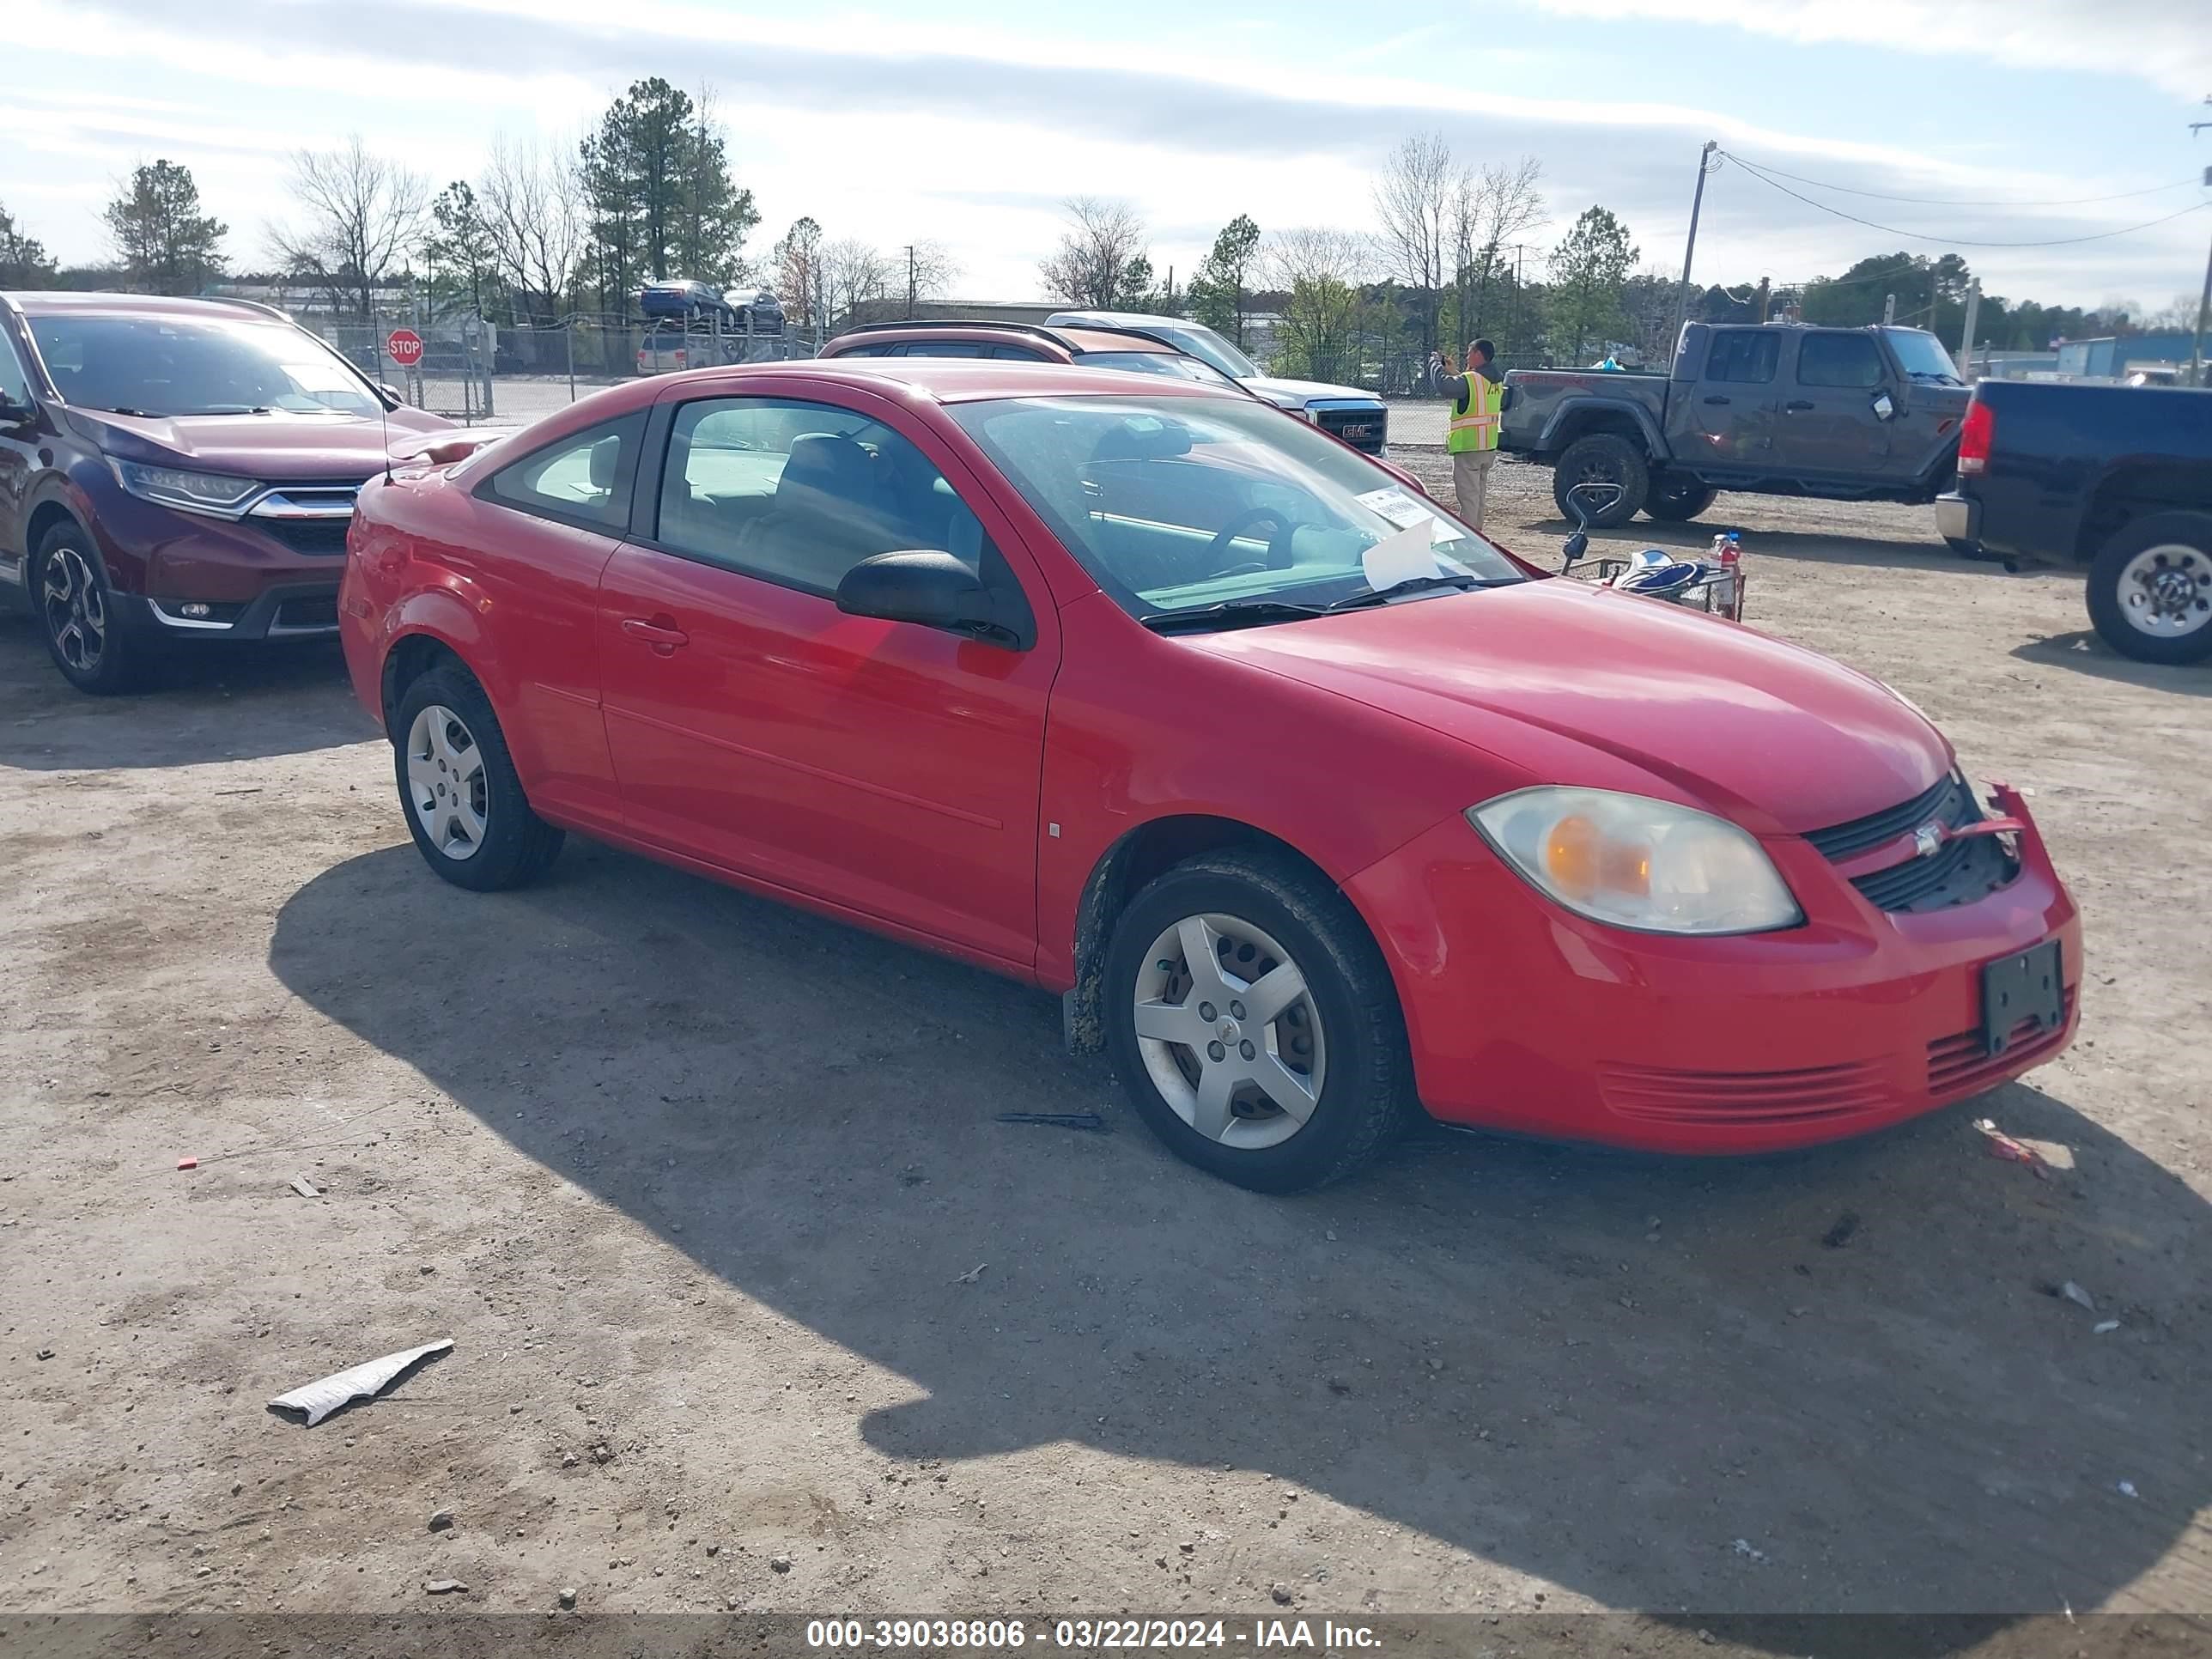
[0,0,2212,307]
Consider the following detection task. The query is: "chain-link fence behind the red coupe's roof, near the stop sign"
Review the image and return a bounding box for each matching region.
[295,314,821,425]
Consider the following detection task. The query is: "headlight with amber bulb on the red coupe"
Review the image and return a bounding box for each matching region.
[1467,787,1805,933]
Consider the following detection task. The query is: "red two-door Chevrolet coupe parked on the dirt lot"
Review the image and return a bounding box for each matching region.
[341,358,2081,1192]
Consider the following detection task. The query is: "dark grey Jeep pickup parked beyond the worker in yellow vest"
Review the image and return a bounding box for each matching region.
[1498,323,1966,526]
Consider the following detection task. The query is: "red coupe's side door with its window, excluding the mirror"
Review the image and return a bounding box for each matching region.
[599,387,1057,971]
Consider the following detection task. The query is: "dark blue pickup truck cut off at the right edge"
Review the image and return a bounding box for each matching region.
[1936,380,2212,664]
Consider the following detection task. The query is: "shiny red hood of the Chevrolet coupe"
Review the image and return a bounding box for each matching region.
[1179,580,1954,834]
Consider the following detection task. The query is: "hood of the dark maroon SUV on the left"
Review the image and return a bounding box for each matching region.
[69,407,453,483]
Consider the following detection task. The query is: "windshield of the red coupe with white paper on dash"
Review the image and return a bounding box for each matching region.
[949,396,1522,626]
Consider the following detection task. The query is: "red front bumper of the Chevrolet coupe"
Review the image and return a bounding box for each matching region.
[1345,792,2081,1152]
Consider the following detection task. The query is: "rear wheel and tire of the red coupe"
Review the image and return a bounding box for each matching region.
[392,668,562,894]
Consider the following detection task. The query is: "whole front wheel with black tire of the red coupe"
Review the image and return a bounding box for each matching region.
[1103,852,1418,1192]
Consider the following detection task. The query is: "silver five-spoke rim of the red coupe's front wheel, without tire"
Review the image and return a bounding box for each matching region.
[1133,914,1328,1151]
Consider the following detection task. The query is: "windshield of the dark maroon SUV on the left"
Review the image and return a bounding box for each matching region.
[31,316,383,416]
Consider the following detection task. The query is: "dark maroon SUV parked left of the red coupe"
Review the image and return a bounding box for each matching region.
[0,295,449,692]
